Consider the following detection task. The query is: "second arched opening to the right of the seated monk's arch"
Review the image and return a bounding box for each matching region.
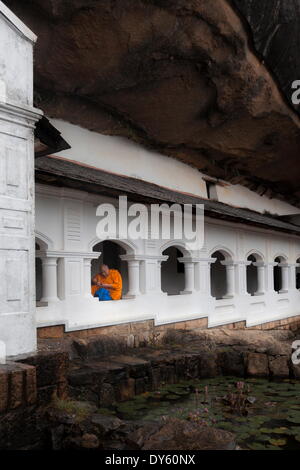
[210,251,234,300]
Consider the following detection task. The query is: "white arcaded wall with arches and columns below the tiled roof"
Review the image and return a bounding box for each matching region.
[36,185,300,331]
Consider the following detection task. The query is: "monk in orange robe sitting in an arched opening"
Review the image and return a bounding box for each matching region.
[92,264,122,301]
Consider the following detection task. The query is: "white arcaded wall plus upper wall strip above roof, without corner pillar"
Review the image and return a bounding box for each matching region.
[36,121,300,332]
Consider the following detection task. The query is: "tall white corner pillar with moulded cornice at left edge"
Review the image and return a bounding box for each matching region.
[0,1,42,356]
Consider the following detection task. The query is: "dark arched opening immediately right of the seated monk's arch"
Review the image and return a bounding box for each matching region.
[161,246,185,295]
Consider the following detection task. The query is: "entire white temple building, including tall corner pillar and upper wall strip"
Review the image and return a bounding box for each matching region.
[0,2,300,356]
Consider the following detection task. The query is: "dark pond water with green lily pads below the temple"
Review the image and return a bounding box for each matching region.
[103,377,300,450]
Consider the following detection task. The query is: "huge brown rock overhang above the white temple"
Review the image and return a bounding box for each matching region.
[5,0,300,204]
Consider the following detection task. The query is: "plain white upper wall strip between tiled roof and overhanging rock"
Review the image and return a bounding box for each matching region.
[51,119,300,215]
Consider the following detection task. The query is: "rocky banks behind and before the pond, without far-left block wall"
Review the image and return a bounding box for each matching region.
[40,329,300,450]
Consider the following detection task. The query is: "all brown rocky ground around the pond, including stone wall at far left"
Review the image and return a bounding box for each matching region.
[0,329,300,450]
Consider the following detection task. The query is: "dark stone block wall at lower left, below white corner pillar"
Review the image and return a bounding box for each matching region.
[0,353,68,450]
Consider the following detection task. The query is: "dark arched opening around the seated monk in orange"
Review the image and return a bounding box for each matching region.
[91,240,129,297]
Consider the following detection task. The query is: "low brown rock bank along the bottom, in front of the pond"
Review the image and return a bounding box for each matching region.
[48,408,236,451]
